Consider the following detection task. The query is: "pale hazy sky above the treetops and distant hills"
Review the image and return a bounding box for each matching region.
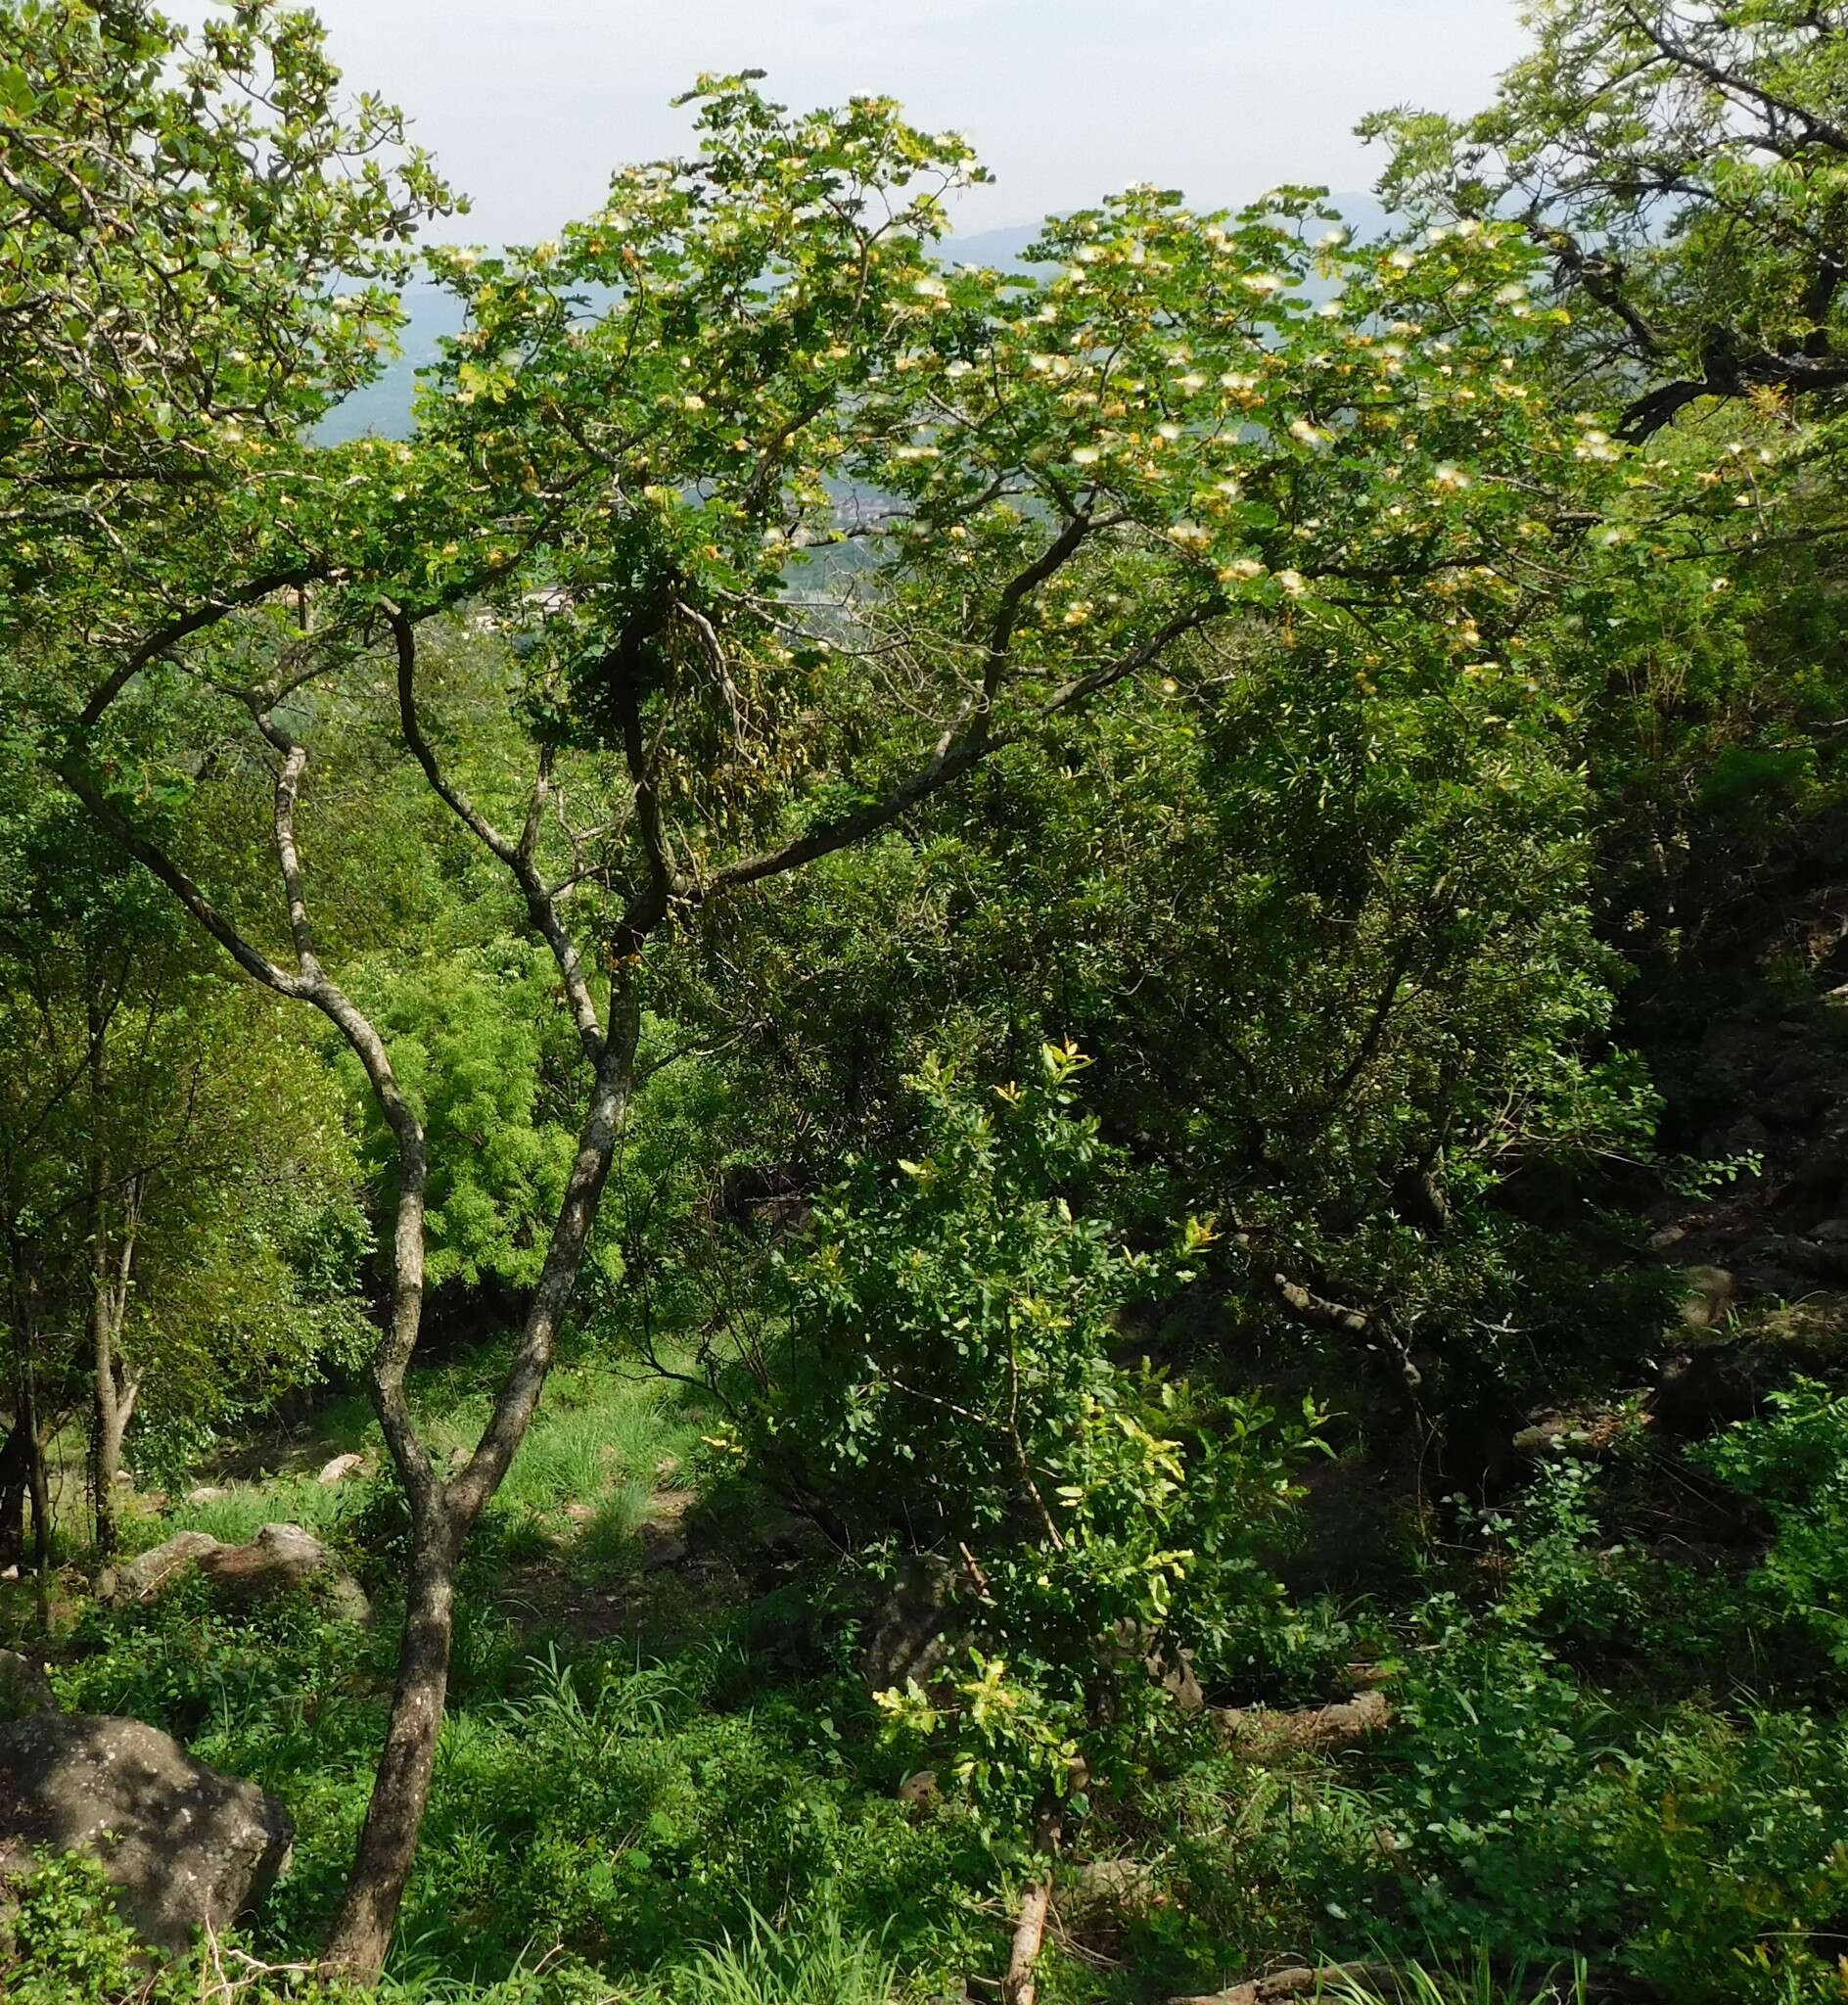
[212,0,1521,243]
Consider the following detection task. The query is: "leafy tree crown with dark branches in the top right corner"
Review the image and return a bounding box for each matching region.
[1363,0,1848,440]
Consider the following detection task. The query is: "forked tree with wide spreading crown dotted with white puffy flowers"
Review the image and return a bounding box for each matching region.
[18,8,1605,1975]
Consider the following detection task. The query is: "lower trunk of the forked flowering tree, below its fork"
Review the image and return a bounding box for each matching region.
[323,1504,461,1982]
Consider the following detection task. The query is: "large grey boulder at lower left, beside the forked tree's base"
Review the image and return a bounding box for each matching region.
[0,1712,295,1955]
